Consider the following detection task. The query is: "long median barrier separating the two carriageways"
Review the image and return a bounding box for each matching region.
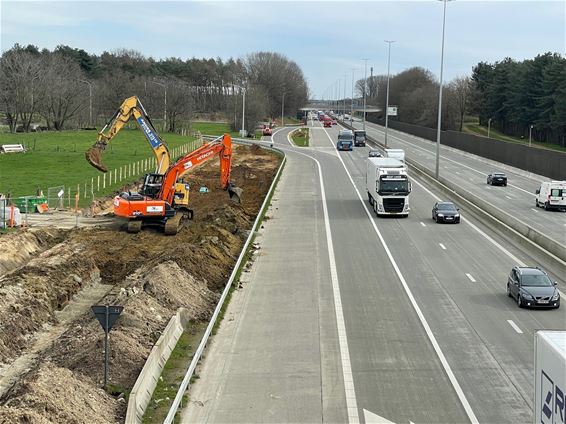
[340,121,566,265]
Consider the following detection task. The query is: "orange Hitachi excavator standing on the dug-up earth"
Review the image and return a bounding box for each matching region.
[114,134,242,234]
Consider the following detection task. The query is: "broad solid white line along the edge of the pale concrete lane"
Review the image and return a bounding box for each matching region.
[287,130,360,424]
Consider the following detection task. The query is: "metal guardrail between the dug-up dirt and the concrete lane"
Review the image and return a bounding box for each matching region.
[163,136,287,424]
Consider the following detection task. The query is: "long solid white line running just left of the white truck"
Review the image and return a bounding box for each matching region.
[325,126,479,424]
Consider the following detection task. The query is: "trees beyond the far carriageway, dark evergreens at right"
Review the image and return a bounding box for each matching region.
[356,53,566,147]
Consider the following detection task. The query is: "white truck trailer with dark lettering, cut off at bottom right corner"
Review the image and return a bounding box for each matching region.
[534,330,566,424]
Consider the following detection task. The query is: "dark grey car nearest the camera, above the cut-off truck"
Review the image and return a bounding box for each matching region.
[507,266,560,308]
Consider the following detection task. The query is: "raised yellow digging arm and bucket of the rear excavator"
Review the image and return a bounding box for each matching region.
[85,96,171,174]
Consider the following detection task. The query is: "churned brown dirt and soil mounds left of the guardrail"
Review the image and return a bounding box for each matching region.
[0,147,279,423]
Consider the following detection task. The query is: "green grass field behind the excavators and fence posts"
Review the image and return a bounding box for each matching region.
[0,122,235,205]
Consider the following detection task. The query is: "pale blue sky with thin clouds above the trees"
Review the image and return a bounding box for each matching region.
[0,0,566,99]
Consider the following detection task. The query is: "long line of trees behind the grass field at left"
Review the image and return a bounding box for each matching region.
[0,44,308,132]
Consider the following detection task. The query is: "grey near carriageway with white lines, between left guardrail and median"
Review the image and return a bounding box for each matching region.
[183,122,566,423]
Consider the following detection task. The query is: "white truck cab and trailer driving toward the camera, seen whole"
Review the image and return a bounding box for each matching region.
[366,158,411,216]
